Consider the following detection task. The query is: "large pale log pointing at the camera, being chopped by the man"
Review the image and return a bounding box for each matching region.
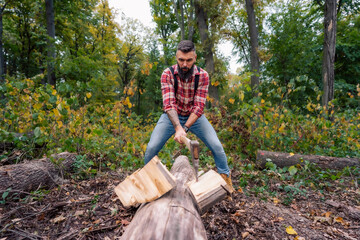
[121,156,207,240]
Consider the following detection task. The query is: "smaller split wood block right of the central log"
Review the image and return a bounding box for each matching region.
[188,170,229,213]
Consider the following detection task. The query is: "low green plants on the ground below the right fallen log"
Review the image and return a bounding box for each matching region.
[239,159,360,205]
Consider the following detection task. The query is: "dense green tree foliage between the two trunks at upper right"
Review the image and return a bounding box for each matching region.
[264,1,322,86]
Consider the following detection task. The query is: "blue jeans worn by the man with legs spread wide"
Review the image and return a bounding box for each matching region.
[144,113,230,175]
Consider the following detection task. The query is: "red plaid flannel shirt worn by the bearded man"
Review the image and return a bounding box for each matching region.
[161,64,209,117]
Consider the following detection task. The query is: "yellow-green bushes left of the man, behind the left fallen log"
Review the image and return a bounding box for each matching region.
[0,79,156,171]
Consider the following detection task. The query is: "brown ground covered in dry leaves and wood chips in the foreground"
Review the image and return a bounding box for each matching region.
[0,168,360,240]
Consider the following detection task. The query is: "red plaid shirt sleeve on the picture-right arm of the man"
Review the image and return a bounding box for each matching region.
[190,69,209,117]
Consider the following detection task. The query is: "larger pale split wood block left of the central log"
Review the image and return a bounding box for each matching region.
[114,156,176,207]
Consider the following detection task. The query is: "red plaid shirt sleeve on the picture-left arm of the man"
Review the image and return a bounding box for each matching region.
[161,68,177,112]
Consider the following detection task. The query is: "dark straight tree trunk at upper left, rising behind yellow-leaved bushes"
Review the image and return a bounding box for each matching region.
[45,0,56,87]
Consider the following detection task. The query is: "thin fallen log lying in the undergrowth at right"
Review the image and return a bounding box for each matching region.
[256,150,360,170]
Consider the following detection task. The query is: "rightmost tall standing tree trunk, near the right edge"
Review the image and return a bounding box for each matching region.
[322,0,337,107]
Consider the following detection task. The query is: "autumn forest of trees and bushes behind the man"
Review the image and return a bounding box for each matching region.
[0,0,360,187]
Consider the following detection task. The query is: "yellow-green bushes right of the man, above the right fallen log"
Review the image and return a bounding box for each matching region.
[215,78,360,159]
